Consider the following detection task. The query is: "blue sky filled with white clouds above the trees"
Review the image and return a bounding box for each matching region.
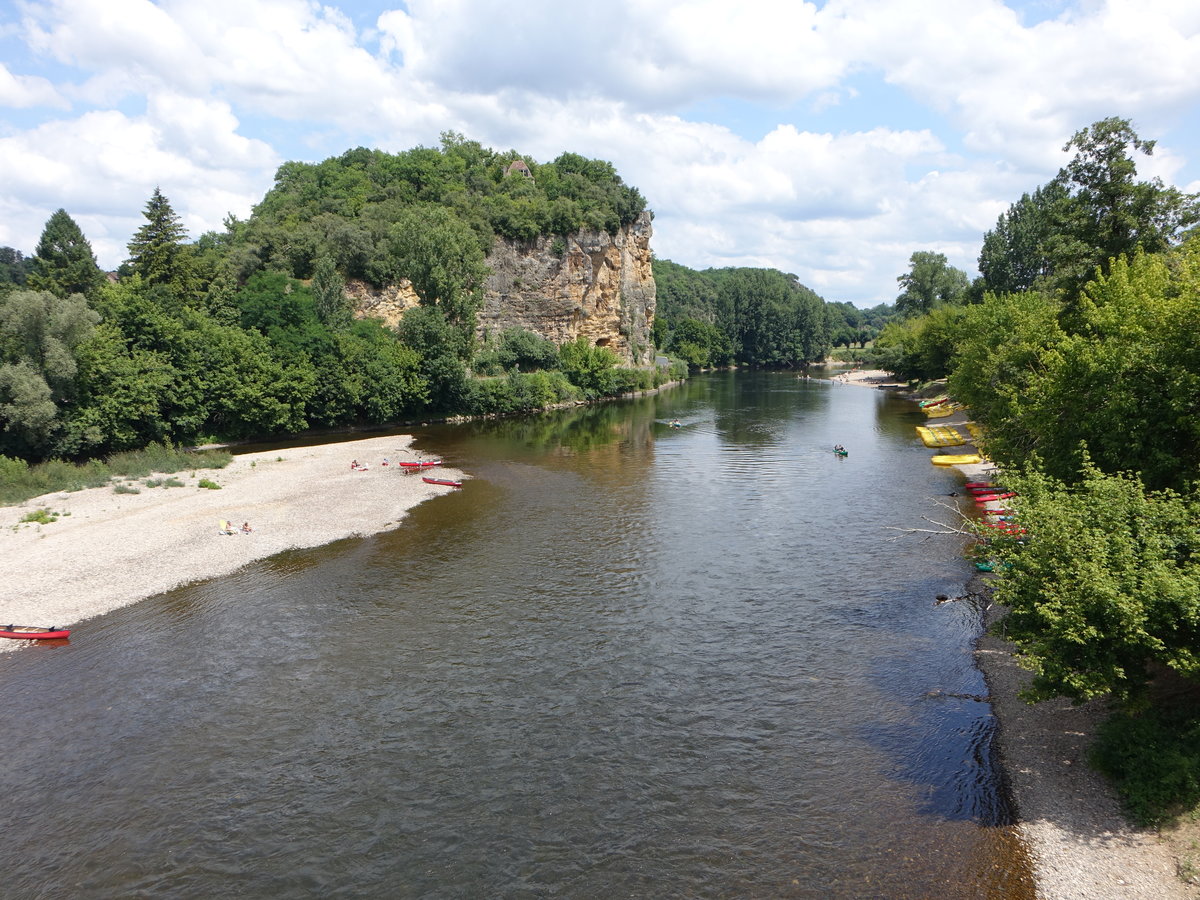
[0,0,1200,307]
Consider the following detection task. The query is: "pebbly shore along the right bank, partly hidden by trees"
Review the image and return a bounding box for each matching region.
[836,370,1200,900]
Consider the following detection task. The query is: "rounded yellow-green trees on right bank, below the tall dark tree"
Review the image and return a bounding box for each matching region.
[949,239,1200,488]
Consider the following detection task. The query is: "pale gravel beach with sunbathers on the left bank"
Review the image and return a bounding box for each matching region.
[0,436,461,652]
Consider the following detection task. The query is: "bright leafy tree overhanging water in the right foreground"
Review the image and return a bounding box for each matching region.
[992,456,1200,701]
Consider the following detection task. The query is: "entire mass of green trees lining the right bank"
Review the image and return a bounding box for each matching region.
[880,119,1200,822]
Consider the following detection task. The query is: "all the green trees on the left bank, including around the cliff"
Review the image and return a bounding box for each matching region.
[0,134,686,461]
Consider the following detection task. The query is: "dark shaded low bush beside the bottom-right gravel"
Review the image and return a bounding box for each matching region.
[1090,709,1200,827]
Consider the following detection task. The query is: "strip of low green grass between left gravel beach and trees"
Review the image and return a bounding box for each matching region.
[0,444,233,506]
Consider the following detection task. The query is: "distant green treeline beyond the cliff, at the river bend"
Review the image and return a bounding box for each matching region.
[654,259,892,370]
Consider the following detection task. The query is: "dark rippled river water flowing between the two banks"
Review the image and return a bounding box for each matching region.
[0,373,1033,900]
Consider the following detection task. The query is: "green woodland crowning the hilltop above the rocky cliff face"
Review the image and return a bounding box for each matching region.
[230,141,646,285]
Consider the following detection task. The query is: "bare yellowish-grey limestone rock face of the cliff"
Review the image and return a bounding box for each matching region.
[347,212,655,365]
